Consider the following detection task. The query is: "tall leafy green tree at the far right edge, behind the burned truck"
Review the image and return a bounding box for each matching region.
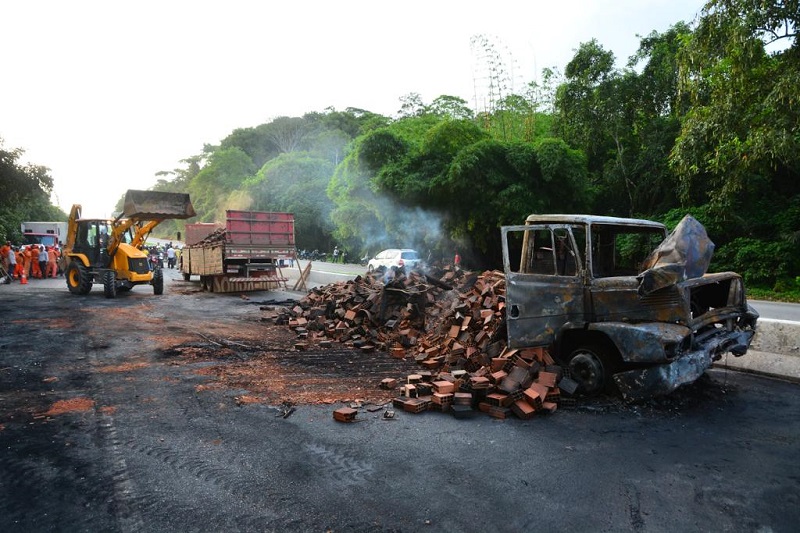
[670,0,800,283]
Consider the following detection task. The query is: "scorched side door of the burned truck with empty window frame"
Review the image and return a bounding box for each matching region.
[502,224,586,348]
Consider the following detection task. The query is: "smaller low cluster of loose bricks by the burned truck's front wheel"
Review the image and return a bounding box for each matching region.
[393,348,574,419]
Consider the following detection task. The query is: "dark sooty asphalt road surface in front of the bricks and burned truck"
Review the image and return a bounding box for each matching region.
[0,272,800,532]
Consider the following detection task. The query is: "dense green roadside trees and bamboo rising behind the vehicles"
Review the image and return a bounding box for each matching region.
[0,0,800,301]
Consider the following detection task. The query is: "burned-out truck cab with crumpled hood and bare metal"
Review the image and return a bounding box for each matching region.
[502,215,758,400]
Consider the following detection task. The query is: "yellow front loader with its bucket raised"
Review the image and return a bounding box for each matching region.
[63,190,195,298]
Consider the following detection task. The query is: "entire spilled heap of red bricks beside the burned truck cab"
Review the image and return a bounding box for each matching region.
[277,269,575,418]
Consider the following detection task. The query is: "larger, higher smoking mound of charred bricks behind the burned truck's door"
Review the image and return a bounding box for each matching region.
[275,269,505,371]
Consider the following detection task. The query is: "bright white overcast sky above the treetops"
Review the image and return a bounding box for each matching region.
[0,0,704,217]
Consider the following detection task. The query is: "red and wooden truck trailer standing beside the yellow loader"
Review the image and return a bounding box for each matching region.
[180,210,297,292]
